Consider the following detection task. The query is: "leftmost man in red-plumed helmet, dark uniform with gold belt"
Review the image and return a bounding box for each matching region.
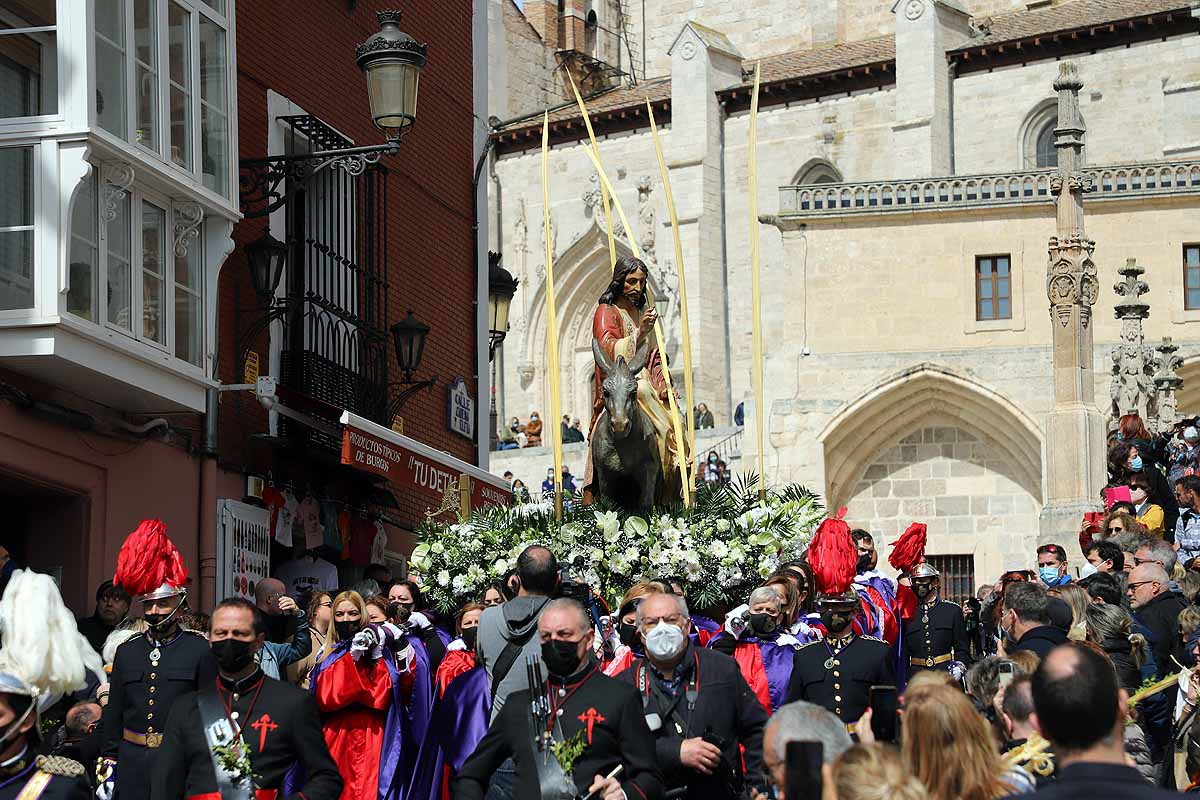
[96,519,216,800]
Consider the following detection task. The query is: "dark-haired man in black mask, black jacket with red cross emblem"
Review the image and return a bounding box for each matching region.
[150,597,342,800]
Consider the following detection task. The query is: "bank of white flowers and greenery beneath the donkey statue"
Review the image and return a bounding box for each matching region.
[412,477,823,612]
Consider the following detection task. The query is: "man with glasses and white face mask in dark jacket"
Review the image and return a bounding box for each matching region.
[618,594,767,800]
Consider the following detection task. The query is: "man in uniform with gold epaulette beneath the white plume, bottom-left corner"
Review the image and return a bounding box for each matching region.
[0,673,91,800]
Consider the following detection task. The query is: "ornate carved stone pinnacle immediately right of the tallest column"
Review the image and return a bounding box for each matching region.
[1109,258,1156,425]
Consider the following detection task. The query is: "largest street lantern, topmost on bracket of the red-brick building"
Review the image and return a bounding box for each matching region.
[355,11,426,142]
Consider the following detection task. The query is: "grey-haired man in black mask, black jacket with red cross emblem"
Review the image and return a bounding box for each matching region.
[450,599,662,800]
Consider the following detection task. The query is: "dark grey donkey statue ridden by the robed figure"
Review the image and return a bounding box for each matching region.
[592,339,662,511]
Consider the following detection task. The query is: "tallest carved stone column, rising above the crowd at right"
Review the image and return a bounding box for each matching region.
[1039,61,1105,543]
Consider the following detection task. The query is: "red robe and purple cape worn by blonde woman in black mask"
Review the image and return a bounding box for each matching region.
[310,636,433,800]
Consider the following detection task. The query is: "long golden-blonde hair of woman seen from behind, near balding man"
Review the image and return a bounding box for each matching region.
[901,686,1033,800]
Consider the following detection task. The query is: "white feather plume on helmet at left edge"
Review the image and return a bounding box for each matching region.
[0,570,103,694]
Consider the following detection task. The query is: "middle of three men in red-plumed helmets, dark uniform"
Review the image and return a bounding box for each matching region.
[786,519,892,734]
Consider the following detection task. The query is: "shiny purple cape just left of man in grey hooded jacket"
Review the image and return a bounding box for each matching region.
[408,667,492,800]
